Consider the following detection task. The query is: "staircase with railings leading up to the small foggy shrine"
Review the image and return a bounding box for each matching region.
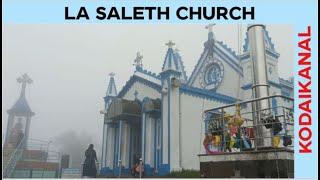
[2,138,25,178]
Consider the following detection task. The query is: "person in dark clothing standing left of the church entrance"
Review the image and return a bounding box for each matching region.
[82,144,98,178]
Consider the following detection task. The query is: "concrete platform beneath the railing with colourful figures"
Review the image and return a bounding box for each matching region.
[198,148,294,178]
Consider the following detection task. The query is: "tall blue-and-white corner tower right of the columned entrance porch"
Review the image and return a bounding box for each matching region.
[159,41,182,175]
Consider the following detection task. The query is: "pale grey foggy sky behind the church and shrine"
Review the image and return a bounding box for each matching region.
[2,24,293,150]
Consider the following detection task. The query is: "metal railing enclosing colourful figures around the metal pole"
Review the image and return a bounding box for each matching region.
[203,95,294,154]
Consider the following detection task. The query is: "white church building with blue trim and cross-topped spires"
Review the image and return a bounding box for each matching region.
[101,27,293,175]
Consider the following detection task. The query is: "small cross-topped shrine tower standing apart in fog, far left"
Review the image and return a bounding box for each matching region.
[5,74,35,148]
